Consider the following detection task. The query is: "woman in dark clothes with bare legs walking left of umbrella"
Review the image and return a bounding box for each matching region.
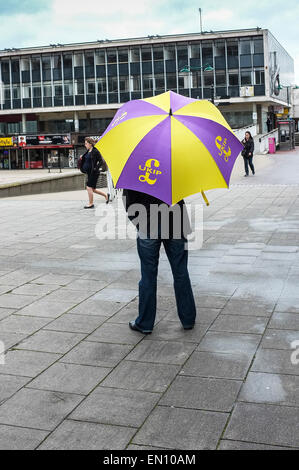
[80,137,110,209]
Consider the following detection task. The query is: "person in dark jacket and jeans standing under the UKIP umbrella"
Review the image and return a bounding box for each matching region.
[123,190,196,334]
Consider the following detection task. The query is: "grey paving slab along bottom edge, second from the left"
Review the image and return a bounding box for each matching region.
[38,420,136,450]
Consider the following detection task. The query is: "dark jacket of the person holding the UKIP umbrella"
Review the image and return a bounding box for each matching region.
[123,189,192,239]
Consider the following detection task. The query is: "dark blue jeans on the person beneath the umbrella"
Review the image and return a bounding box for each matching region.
[135,237,196,331]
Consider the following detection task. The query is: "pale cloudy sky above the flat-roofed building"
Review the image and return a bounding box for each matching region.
[0,0,299,81]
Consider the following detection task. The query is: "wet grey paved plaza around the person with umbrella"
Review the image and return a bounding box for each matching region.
[0,149,299,450]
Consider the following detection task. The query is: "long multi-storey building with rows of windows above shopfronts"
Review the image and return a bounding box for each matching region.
[0,28,294,168]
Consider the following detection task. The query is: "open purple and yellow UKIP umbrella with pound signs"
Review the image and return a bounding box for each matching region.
[96,91,243,205]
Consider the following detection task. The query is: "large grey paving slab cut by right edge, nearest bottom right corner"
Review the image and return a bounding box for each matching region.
[224,403,299,447]
